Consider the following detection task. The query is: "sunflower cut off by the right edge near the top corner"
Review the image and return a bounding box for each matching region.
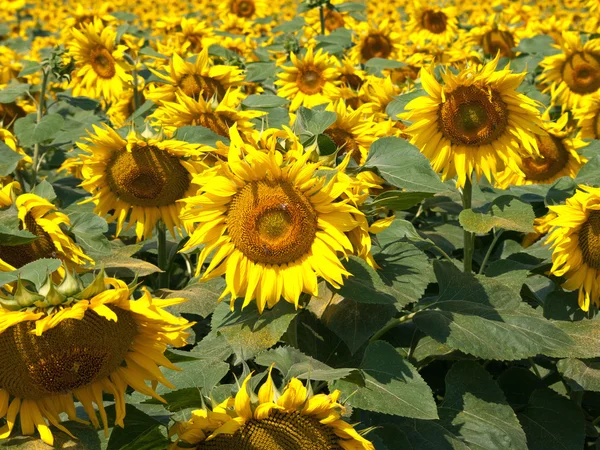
[539,31,600,112]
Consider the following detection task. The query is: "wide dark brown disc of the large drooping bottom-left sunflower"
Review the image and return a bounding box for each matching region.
[0,306,137,400]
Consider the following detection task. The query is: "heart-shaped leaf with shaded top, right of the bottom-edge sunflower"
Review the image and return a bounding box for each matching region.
[332,341,438,419]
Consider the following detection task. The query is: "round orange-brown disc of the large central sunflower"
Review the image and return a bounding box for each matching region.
[227,180,317,264]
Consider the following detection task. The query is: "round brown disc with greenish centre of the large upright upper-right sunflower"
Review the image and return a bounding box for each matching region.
[438,85,508,146]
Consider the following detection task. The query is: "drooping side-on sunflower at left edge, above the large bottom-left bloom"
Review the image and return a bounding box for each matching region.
[0,182,94,272]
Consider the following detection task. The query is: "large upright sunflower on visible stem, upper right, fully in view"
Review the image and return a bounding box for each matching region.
[401,56,545,187]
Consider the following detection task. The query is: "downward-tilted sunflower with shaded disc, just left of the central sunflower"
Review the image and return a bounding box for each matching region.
[78,125,205,240]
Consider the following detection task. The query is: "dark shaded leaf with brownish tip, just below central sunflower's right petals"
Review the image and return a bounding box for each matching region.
[321,297,397,354]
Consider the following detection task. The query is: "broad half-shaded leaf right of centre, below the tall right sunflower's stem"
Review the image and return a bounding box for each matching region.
[413,261,572,360]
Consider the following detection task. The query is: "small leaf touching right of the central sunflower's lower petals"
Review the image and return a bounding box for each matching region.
[374,243,433,310]
